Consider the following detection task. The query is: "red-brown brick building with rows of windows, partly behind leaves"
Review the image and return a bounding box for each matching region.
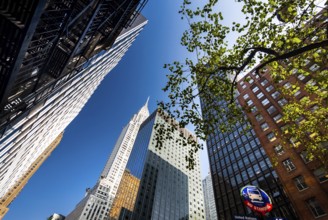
[238,60,328,219]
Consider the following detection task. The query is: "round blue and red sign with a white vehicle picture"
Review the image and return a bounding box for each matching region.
[240,185,272,215]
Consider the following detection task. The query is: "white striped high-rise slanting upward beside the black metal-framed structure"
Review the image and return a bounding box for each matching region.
[0,9,147,212]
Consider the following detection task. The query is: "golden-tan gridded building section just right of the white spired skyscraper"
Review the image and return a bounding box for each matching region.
[109,170,140,220]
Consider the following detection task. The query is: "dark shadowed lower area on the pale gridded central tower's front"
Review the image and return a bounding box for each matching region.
[132,150,189,220]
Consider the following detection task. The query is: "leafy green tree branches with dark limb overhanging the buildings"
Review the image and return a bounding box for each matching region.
[157,0,328,168]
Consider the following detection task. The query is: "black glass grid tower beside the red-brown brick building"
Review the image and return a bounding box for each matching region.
[202,102,297,219]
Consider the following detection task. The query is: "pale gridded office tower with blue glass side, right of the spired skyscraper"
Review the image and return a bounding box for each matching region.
[119,110,205,220]
